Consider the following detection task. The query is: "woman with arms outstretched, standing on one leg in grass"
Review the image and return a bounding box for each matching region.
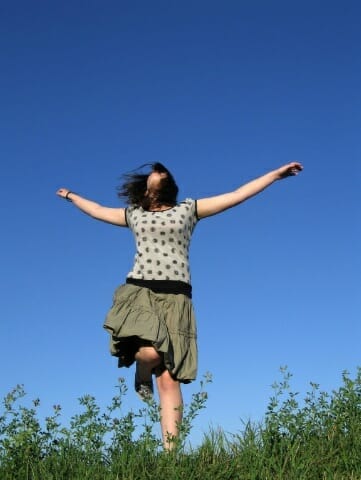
[57,162,302,448]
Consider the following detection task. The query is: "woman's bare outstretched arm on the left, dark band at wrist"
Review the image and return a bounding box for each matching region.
[56,188,127,227]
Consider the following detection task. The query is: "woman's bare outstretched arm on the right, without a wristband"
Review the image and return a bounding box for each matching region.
[197,162,303,218]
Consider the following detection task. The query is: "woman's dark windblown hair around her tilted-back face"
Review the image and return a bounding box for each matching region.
[117,162,178,209]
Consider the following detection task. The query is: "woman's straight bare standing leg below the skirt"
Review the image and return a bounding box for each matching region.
[157,370,183,450]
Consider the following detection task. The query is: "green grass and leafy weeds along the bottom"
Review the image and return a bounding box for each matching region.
[0,368,361,480]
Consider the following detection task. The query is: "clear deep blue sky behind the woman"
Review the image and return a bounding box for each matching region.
[0,0,361,441]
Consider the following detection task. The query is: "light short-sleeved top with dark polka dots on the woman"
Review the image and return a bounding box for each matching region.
[126,199,198,284]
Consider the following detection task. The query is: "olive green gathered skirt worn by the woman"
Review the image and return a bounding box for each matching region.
[104,284,197,383]
